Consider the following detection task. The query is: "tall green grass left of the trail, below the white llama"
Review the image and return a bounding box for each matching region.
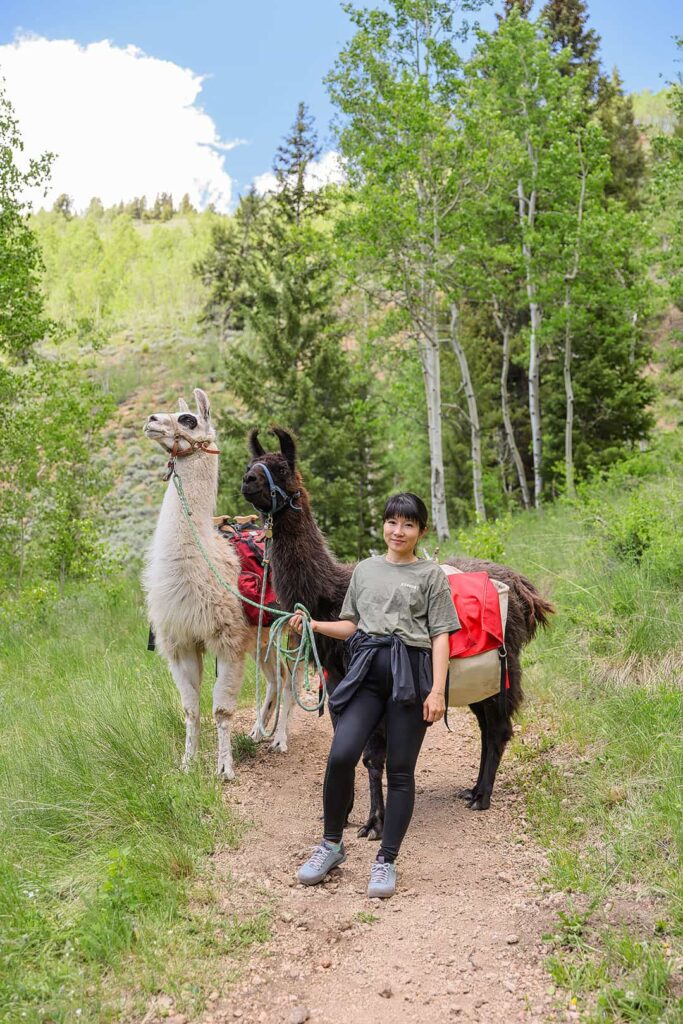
[0,581,268,1024]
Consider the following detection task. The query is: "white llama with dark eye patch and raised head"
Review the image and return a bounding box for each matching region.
[142,388,292,779]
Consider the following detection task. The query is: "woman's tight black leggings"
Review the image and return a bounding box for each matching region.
[323,647,427,861]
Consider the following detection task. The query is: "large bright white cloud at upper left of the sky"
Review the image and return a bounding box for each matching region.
[0,37,241,211]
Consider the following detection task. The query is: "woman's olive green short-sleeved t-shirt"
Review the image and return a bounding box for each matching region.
[339,555,460,650]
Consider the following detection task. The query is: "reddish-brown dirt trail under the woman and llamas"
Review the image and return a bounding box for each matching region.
[202,709,575,1024]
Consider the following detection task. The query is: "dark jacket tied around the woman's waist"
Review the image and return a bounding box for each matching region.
[329,630,432,715]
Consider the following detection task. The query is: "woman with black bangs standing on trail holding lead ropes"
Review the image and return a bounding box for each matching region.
[292,493,460,898]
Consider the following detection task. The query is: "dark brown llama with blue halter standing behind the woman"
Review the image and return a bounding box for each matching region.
[242,427,554,839]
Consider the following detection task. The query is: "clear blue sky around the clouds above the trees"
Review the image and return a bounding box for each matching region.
[0,0,683,207]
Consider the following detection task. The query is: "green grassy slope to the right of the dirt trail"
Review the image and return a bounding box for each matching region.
[456,437,683,1024]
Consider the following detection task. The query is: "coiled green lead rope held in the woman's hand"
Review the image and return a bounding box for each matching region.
[171,465,327,739]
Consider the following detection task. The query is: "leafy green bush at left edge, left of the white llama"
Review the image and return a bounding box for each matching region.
[0,358,112,584]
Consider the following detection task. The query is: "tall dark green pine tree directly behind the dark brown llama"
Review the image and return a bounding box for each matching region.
[197,105,381,558]
